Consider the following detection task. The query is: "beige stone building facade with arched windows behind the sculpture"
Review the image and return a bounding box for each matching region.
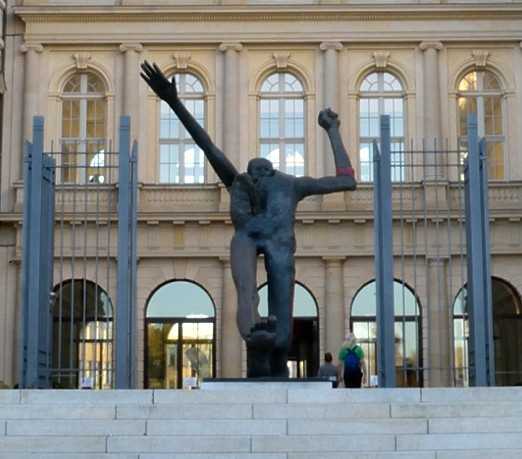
[0,0,522,387]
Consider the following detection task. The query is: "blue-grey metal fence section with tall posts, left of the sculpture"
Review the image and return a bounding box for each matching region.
[21,117,137,389]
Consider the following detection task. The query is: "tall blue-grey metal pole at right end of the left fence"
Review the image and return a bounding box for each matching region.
[115,116,133,389]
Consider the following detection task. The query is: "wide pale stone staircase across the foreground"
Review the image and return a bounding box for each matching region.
[0,386,522,459]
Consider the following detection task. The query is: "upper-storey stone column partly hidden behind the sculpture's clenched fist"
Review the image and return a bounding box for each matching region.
[319,41,343,175]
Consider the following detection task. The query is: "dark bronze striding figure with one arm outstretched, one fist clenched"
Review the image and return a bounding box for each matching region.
[141,61,356,377]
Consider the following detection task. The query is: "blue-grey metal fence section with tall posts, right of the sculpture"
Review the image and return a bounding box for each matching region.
[374,113,494,387]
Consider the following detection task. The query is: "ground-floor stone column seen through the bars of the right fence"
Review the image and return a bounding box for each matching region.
[425,258,451,387]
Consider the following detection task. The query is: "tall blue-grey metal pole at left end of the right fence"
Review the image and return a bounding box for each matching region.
[373,115,395,387]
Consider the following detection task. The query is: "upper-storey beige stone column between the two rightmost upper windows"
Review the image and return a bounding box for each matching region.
[419,41,443,180]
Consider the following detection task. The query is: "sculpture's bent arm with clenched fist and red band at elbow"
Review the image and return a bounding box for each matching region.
[296,108,357,199]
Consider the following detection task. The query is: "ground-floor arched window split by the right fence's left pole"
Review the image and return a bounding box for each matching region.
[350,281,422,387]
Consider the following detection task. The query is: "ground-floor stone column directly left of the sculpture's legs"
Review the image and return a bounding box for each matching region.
[221,257,243,378]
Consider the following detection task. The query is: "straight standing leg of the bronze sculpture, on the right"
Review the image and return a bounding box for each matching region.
[265,246,295,377]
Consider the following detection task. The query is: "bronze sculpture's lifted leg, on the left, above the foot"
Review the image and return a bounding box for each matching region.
[230,233,259,340]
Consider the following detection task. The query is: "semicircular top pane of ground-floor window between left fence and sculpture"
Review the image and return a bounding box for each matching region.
[147,281,215,318]
